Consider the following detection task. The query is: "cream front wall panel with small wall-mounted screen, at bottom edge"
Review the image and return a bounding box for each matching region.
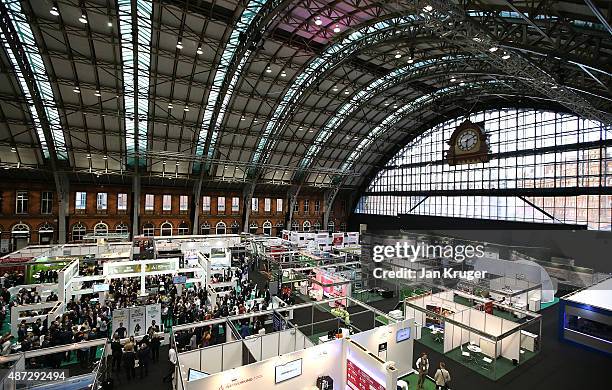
[187,340,346,390]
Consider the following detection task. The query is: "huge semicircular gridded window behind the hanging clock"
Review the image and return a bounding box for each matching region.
[355,109,612,230]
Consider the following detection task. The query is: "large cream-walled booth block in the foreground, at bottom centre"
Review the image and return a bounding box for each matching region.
[175,303,416,390]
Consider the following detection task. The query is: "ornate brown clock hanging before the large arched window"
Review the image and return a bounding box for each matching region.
[446,120,491,165]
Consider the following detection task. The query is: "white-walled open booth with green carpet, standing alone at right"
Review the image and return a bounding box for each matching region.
[404,290,541,380]
